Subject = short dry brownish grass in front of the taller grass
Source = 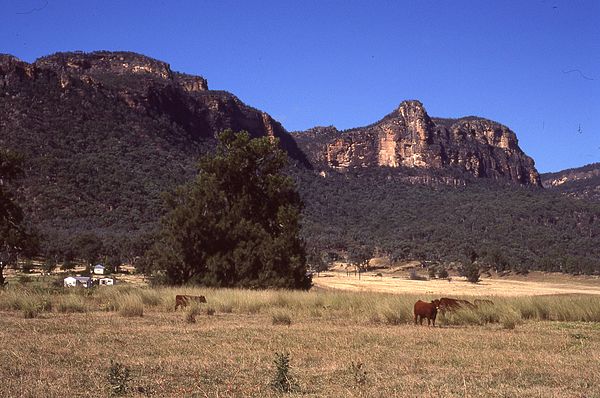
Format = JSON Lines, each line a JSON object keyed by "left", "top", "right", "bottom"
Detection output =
{"left": 0, "top": 302, "right": 600, "bottom": 398}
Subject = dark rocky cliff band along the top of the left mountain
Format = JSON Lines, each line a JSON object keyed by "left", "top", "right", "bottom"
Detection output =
{"left": 0, "top": 51, "right": 305, "bottom": 162}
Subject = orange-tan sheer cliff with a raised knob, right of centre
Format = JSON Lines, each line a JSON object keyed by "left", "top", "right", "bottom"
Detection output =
{"left": 294, "top": 101, "right": 540, "bottom": 186}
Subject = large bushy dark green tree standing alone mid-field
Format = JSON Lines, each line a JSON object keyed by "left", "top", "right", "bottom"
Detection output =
{"left": 145, "top": 130, "right": 311, "bottom": 289}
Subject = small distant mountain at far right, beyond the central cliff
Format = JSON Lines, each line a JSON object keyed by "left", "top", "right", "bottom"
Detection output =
{"left": 541, "top": 163, "right": 600, "bottom": 201}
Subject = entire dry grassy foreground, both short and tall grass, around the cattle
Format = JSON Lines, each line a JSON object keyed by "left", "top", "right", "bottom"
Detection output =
{"left": 0, "top": 288, "right": 600, "bottom": 397}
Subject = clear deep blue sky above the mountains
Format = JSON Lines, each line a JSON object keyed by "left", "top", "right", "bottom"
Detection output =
{"left": 0, "top": 0, "right": 600, "bottom": 172}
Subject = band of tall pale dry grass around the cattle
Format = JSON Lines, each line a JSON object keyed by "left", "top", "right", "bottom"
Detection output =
{"left": 0, "top": 285, "right": 600, "bottom": 329}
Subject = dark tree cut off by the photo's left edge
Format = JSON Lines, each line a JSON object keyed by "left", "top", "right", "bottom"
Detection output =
{"left": 0, "top": 149, "right": 39, "bottom": 287}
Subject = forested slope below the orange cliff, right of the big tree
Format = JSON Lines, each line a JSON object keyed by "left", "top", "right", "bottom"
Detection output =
{"left": 296, "top": 170, "right": 600, "bottom": 273}
